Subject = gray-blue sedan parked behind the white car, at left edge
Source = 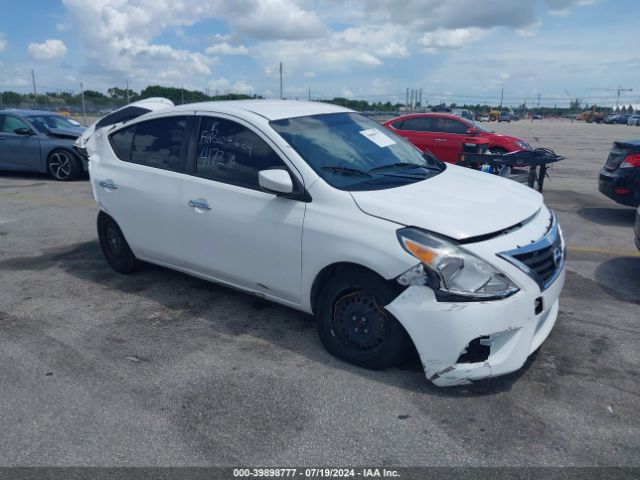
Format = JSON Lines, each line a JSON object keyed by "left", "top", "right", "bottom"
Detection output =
{"left": 0, "top": 110, "right": 87, "bottom": 180}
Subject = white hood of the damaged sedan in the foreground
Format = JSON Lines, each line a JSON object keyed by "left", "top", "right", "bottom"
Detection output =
{"left": 351, "top": 165, "right": 542, "bottom": 240}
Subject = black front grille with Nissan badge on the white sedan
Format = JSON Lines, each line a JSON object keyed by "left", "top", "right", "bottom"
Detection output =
{"left": 499, "top": 214, "right": 566, "bottom": 290}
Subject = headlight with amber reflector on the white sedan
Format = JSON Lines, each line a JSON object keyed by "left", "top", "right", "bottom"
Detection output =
{"left": 397, "top": 228, "right": 518, "bottom": 301}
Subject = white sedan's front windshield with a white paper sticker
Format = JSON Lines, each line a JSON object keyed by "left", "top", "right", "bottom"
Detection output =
{"left": 271, "top": 113, "right": 445, "bottom": 191}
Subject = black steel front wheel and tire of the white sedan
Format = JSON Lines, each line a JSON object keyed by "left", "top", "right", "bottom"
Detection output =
{"left": 316, "top": 270, "right": 411, "bottom": 370}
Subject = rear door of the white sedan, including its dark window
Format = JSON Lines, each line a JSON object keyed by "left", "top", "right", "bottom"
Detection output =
{"left": 91, "top": 115, "right": 195, "bottom": 266}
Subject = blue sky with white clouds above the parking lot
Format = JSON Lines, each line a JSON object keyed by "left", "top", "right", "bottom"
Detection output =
{"left": 0, "top": 0, "right": 640, "bottom": 106}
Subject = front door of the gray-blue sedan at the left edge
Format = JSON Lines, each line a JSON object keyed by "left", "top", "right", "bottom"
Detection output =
{"left": 0, "top": 114, "right": 43, "bottom": 171}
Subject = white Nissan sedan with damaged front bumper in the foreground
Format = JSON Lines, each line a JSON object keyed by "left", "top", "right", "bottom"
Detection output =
{"left": 89, "top": 100, "right": 565, "bottom": 386}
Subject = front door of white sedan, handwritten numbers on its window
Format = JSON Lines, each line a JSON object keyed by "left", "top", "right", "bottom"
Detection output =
{"left": 180, "top": 115, "right": 306, "bottom": 303}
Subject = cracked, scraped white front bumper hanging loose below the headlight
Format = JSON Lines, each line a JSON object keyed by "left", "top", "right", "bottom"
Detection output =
{"left": 386, "top": 269, "right": 565, "bottom": 386}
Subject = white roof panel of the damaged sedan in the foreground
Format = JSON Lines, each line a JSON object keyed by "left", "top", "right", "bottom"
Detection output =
{"left": 168, "top": 100, "right": 353, "bottom": 120}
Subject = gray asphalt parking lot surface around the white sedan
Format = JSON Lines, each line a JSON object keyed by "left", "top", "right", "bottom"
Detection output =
{"left": 0, "top": 120, "right": 640, "bottom": 466}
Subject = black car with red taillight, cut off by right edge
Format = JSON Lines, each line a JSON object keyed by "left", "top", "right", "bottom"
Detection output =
{"left": 598, "top": 139, "right": 640, "bottom": 207}
